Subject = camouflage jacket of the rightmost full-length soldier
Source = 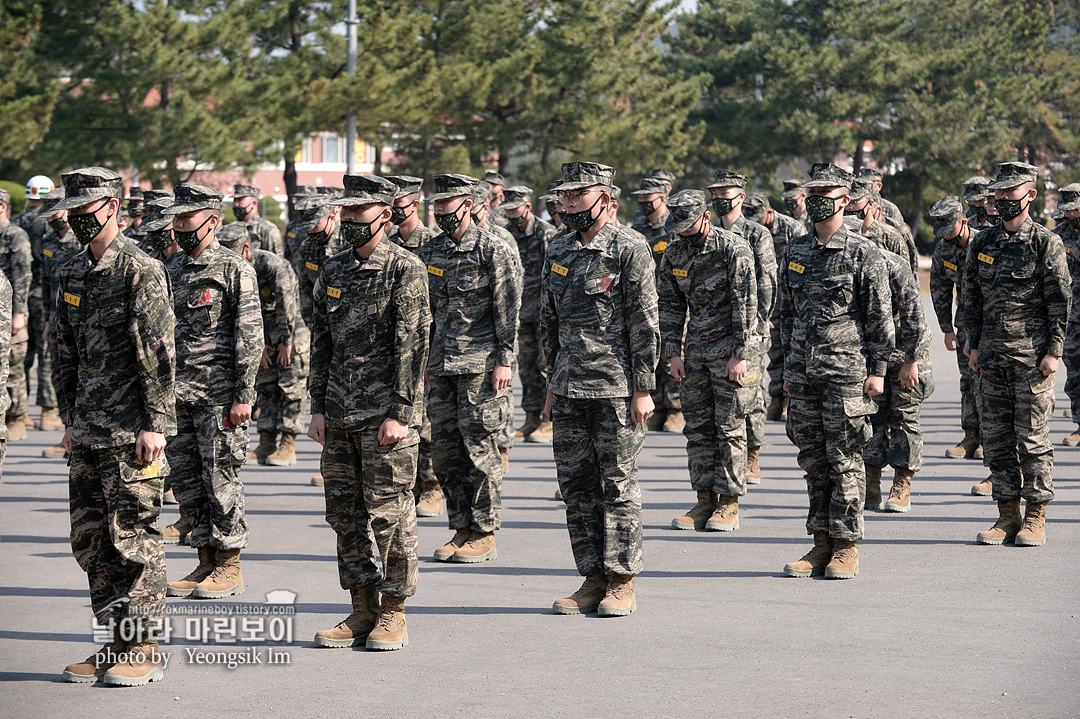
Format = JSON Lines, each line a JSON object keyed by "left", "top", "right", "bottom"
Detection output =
{"left": 963, "top": 218, "right": 1072, "bottom": 367}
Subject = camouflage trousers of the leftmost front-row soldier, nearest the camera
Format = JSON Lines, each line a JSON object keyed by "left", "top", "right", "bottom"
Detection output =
{"left": 68, "top": 444, "right": 170, "bottom": 625}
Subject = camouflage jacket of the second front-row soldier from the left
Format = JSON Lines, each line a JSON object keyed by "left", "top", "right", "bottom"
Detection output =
{"left": 309, "top": 238, "right": 429, "bottom": 430}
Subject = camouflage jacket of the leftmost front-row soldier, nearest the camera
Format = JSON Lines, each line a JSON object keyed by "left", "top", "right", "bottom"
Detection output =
{"left": 52, "top": 235, "right": 176, "bottom": 449}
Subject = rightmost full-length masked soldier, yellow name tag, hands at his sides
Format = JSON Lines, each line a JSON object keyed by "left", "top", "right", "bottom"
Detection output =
{"left": 963, "top": 162, "right": 1072, "bottom": 546}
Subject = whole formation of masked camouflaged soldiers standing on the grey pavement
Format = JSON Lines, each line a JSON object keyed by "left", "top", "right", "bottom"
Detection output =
{"left": 0, "top": 154, "right": 1080, "bottom": 686}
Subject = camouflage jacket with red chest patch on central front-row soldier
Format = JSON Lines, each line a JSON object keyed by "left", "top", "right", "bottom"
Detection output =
{"left": 540, "top": 221, "right": 660, "bottom": 398}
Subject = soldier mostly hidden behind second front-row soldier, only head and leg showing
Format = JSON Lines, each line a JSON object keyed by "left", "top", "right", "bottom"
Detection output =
{"left": 387, "top": 175, "right": 443, "bottom": 517}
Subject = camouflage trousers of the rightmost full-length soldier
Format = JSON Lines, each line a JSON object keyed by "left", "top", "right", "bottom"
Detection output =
{"left": 978, "top": 364, "right": 1055, "bottom": 502}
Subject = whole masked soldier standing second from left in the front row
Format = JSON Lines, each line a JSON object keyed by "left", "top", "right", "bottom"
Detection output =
{"left": 308, "top": 175, "right": 431, "bottom": 650}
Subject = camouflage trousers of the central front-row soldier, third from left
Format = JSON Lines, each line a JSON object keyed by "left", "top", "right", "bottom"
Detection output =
{"left": 551, "top": 394, "right": 645, "bottom": 576}
